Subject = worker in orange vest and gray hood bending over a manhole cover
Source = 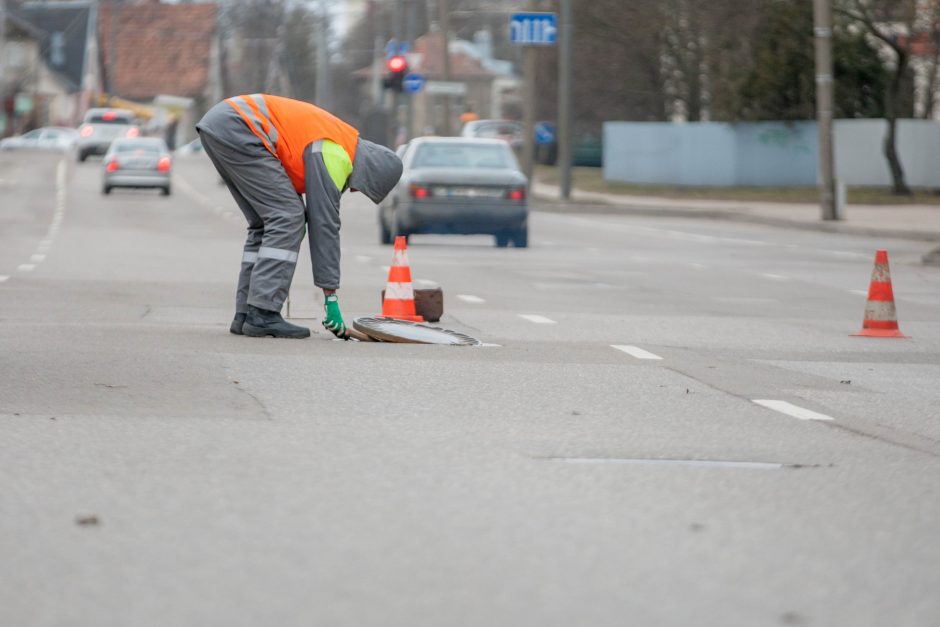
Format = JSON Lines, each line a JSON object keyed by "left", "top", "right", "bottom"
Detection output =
{"left": 196, "top": 94, "right": 402, "bottom": 339}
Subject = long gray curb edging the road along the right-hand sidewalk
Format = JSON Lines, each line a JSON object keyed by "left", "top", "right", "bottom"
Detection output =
{"left": 532, "top": 193, "right": 940, "bottom": 242}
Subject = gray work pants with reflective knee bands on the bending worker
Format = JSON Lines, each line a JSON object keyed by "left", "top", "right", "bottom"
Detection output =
{"left": 198, "top": 123, "right": 306, "bottom": 313}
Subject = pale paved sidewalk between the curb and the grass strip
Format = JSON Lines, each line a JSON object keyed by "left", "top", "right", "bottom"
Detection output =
{"left": 532, "top": 181, "right": 940, "bottom": 242}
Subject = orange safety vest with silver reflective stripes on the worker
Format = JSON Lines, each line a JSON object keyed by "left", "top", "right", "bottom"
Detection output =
{"left": 226, "top": 94, "right": 359, "bottom": 194}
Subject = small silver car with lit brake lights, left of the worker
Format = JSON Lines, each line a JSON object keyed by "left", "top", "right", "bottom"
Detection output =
{"left": 101, "top": 137, "right": 173, "bottom": 196}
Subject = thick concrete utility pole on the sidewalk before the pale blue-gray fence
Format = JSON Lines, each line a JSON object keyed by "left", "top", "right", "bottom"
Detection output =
{"left": 813, "top": 0, "right": 841, "bottom": 220}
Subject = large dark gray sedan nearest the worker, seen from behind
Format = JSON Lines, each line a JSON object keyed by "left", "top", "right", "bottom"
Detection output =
{"left": 379, "top": 137, "right": 529, "bottom": 248}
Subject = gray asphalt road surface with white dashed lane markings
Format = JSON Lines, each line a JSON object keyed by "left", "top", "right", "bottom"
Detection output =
{"left": 0, "top": 153, "right": 940, "bottom": 627}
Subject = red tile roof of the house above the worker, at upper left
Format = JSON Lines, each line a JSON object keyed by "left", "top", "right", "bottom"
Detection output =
{"left": 98, "top": 2, "right": 218, "bottom": 100}
